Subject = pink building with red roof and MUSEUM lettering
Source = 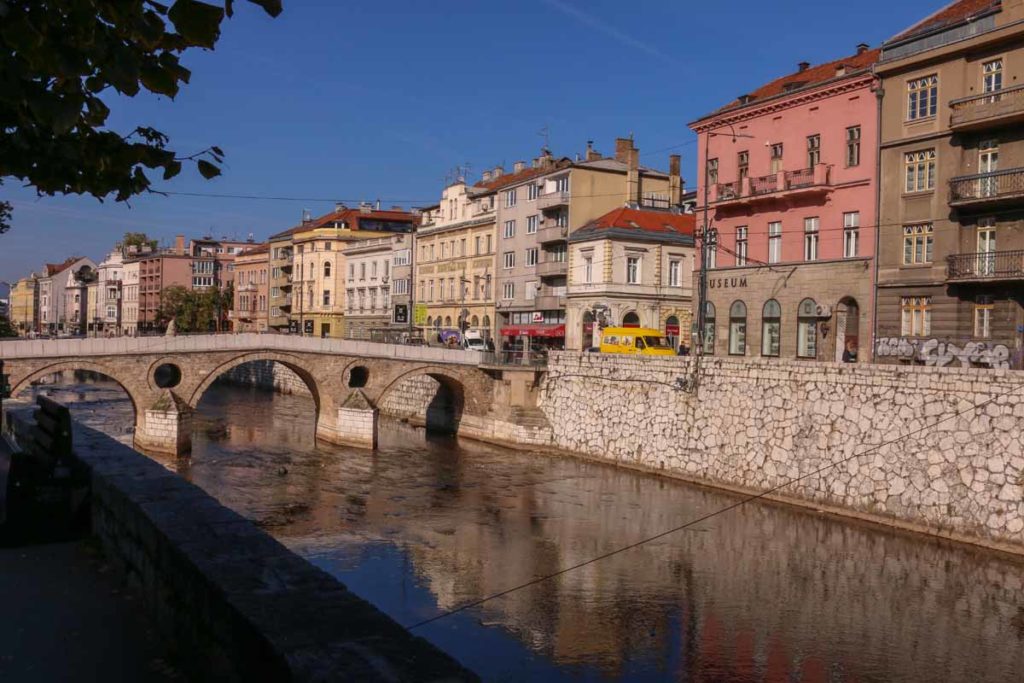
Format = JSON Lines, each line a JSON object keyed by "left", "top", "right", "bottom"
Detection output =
{"left": 690, "top": 45, "right": 879, "bottom": 361}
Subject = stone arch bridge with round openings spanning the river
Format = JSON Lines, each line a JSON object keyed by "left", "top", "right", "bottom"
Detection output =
{"left": 0, "top": 334, "right": 539, "bottom": 455}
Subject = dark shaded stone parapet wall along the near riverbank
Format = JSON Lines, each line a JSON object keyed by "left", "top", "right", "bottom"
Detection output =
{"left": 5, "top": 401, "right": 478, "bottom": 682}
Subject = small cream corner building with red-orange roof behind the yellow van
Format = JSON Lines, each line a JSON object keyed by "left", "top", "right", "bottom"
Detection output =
{"left": 565, "top": 204, "right": 695, "bottom": 350}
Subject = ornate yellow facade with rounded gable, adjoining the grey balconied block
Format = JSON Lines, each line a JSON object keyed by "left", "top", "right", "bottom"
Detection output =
{"left": 413, "top": 179, "right": 497, "bottom": 342}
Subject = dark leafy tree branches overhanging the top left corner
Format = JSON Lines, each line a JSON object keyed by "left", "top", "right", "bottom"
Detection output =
{"left": 0, "top": 0, "right": 282, "bottom": 232}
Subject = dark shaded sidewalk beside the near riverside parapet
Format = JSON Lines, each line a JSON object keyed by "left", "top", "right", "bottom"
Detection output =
{"left": 0, "top": 438, "right": 185, "bottom": 683}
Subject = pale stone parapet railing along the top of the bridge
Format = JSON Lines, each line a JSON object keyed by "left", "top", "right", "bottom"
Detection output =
{"left": 0, "top": 333, "right": 483, "bottom": 366}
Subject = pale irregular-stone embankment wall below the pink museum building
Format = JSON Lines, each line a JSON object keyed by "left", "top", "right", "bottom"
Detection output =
{"left": 541, "top": 352, "right": 1024, "bottom": 552}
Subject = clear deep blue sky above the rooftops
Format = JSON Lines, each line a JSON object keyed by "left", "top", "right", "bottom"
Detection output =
{"left": 0, "top": 0, "right": 941, "bottom": 281}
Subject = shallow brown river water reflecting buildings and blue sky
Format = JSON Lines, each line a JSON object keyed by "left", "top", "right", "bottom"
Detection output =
{"left": 19, "top": 382, "right": 1024, "bottom": 683}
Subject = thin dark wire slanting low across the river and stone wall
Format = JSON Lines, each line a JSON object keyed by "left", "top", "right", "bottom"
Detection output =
{"left": 406, "top": 374, "right": 1024, "bottom": 631}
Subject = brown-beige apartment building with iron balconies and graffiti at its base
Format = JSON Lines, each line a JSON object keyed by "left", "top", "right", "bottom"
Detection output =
{"left": 874, "top": 0, "right": 1024, "bottom": 368}
